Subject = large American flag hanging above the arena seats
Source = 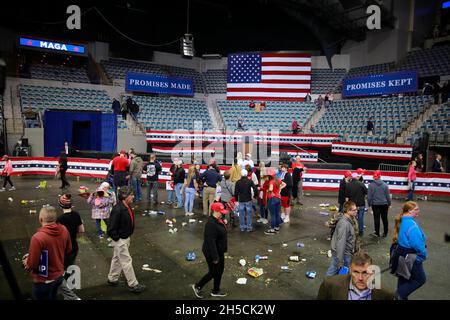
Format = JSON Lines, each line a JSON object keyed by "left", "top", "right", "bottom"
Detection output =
{"left": 227, "top": 52, "right": 311, "bottom": 100}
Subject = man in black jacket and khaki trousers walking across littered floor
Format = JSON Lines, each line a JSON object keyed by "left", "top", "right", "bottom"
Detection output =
{"left": 108, "top": 186, "right": 145, "bottom": 293}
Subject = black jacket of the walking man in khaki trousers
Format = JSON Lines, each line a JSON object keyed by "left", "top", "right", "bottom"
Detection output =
{"left": 107, "top": 201, "right": 134, "bottom": 241}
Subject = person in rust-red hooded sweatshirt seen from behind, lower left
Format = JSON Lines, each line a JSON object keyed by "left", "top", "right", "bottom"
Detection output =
{"left": 22, "top": 206, "right": 72, "bottom": 300}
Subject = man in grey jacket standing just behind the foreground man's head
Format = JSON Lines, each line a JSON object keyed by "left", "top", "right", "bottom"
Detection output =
{"left": 326, "top": 201, "right": 357, "bottom": 276}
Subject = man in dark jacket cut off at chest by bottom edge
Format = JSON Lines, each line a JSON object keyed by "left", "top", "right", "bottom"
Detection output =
{"left": 317, "top": 251, "right": 394, "bottom": 300}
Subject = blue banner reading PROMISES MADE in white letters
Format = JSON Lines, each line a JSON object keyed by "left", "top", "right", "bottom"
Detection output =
{"left": 125, "top": 72, "right": 194, "bottom": 96}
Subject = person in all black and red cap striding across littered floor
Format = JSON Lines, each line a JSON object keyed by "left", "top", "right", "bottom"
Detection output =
{"left": 191, "top": 202, "right": 228, "bottom": 299}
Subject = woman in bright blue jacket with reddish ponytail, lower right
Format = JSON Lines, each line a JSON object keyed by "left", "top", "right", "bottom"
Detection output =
{"left": 393, "top": 201, "right": 427, "bottom": 300}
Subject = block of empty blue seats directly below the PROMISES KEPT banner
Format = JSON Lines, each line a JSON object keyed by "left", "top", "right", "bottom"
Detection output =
{"left": 315, "top": 96, "right": 432, "bottom": 143}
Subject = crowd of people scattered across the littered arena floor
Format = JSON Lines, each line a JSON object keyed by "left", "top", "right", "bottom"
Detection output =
{"left": 5, "top": 149, "right": 442, "bottom": 300}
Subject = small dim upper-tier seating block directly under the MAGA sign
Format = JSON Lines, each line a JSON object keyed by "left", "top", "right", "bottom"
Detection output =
{"left": 30, "top": 65, "right": 89, "bottom": 83}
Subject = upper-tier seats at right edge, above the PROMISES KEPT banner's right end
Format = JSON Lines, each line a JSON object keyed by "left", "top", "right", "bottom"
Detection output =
{"left": 398, "top": 46, "right": 450, "bottom": 77}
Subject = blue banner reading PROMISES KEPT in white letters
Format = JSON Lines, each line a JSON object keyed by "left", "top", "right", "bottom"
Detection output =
{"left": 342, "top": 71, "right": 418, "bottom": 98}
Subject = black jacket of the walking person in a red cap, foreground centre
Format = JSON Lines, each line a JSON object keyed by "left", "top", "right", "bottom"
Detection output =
{"left": 202, "top": 215, "right": 228, "bottom": 261}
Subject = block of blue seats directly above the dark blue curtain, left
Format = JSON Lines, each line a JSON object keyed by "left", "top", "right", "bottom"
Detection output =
{"left": 19, "top": 84, "right": 112, "bottom": 112}
